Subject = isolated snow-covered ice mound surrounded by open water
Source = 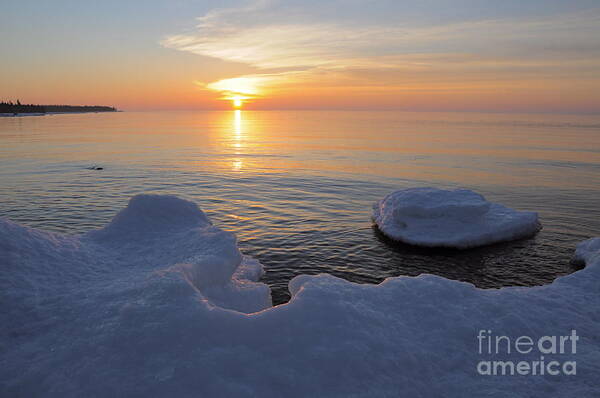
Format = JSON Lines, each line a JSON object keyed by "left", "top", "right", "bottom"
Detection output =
{"left": 373, "top": 188, "right": 540, "bottom": 249}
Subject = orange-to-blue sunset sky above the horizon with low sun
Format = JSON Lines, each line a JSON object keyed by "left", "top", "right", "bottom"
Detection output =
{"left": 0, "top": 0, "right": 600, "bottom": 113}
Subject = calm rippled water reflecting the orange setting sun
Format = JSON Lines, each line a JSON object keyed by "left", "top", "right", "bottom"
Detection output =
{"left": 0, "top": 111, "right": 600, "bottom": 303}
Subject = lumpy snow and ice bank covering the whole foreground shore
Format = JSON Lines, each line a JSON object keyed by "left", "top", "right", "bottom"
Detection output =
{"left": 0, "top": 195, "right": 600, "bottom": 397}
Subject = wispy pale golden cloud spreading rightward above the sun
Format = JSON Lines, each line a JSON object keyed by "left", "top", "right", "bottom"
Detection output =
{"left": 161, "top": 0, "right": 600, "bottom": 105}
